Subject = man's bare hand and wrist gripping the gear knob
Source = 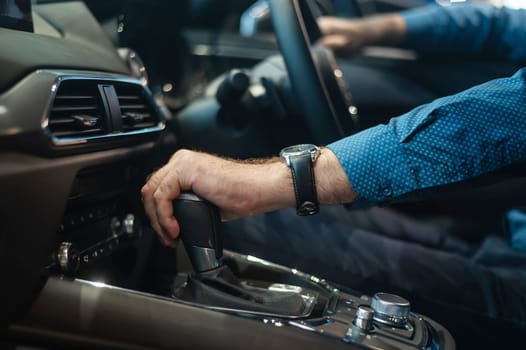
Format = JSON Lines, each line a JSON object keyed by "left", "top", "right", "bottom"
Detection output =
{"left": 141, "top": 148, "right": 356, "bottom": 246}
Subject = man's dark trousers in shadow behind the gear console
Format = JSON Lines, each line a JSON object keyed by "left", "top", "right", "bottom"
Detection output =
{"left": 224, "top": 206, "right": 526, "bottom": 349}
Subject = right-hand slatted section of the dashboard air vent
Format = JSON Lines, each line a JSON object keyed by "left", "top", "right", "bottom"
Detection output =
{"left": 115, "top": 84, "right": 159, "bottom": 132}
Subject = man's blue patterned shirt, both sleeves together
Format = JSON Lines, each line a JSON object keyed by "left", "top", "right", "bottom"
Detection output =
{"left": 328, "top": 5, "right": 526, "bottom": 248}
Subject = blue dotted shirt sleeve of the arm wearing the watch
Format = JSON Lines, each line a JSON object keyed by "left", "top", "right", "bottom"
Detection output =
{"left": 328, "top": 68, "right": 526, "bottom": 205}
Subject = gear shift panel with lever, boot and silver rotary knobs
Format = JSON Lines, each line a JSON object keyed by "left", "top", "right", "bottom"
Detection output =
{"left": 168, "top": 193, "right": 455, "bottom": 349}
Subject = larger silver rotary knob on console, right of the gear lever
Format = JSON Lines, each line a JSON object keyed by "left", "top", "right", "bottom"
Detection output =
{"left": 371, "top": 293, "right": 411, "bottom": 327}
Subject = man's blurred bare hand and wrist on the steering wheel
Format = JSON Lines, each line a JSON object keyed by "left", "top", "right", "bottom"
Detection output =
{"left": 317, "top": 14, "right": 406, "bottom": 56}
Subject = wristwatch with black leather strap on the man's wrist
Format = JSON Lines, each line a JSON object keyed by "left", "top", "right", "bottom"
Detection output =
{"left": 279, "top": 144, "right": 320, "bottom": 215}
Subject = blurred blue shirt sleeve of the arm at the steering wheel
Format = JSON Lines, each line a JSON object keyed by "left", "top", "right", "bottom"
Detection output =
{"left": 401, "top": 4, "right": 526, "bottom": 62}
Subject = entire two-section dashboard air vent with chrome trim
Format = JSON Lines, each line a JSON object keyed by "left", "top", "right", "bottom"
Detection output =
{"left": 45, "top": 74, "right": 164, "bottom": 149}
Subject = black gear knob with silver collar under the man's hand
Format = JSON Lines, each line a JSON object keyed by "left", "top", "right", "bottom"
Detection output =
{"left": 173, "top": 192, "right": 223, "bottom": 273}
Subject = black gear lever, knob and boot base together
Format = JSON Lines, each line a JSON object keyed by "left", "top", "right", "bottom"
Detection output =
{"left": 173, "top": 192, "right": 312, "bottom": 316}
